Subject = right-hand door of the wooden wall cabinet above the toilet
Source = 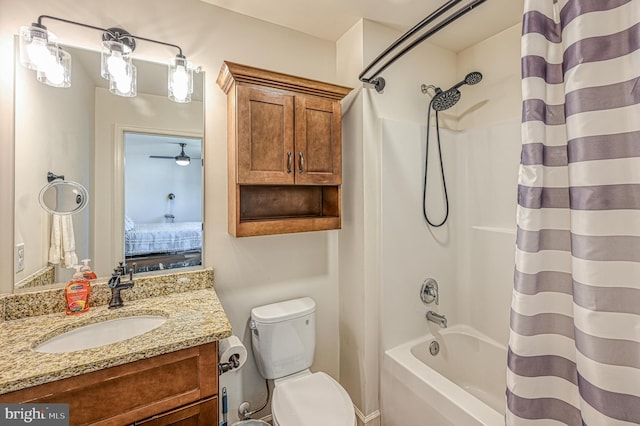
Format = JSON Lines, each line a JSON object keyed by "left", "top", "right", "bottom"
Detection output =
{"left": 295, "top": 96, "right": 342, "bottom": 185}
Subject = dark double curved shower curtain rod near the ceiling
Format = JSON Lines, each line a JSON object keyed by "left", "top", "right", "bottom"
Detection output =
{"left": 358, "top": 0, "right": 486, "bottom": 93}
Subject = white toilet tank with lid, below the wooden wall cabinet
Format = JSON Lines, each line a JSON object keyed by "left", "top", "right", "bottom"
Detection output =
{"left": 250, "top": 297, "right": 316, "bottom": 379}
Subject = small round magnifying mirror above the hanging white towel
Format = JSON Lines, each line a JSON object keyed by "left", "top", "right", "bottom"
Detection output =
{"left": 40, "top": 180, "right": 89, "bottom": 214}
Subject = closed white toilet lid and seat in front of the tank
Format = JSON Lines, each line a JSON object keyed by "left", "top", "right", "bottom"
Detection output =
{"left": 271, "top": 372, "right": 356, "bottom": 426}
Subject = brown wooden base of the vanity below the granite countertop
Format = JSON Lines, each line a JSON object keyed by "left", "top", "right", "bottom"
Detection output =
{"left": 0, "top": 342, "right": 218, "bottom": 426}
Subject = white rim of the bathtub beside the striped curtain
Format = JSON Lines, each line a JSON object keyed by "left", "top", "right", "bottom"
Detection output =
{"left": 385, "top": 324, "right": 506, "bottom": 426}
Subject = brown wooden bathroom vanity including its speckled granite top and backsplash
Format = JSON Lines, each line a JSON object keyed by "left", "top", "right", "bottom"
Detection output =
{"left": 0, "top": 270, "right": 231, "bottom": 426}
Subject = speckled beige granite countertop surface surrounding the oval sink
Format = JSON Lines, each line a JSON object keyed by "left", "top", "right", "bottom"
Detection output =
{"left": 0, "top": 270, "right": 231, "bottom": 394}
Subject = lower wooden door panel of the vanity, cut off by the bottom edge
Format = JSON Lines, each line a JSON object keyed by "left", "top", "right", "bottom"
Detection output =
{"left": 134, "top": 397, "right": 218, "bottom": 426}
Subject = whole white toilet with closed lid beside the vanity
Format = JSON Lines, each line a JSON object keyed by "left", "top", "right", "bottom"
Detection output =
{"left": 251, "top": 297, "right": 356, "bottom": 426}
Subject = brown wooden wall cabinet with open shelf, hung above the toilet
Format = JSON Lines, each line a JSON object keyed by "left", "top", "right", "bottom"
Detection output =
{"left": 218, "top": 62, "right": 351, "bottom": 237}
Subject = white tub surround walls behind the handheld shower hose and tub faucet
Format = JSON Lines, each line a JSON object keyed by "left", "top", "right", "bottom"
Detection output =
{"left": 380, "top": 25, "right": 521, "bottom": 360}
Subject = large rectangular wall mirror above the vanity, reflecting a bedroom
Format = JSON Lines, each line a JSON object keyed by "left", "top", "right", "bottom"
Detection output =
{"left": 14, "top": 39, "right": 204, "bottom": 289}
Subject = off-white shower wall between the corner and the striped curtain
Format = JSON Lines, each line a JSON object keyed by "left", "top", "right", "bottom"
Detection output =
{"left": 456, "top": 24, "right": 522, "bottom": 345}
